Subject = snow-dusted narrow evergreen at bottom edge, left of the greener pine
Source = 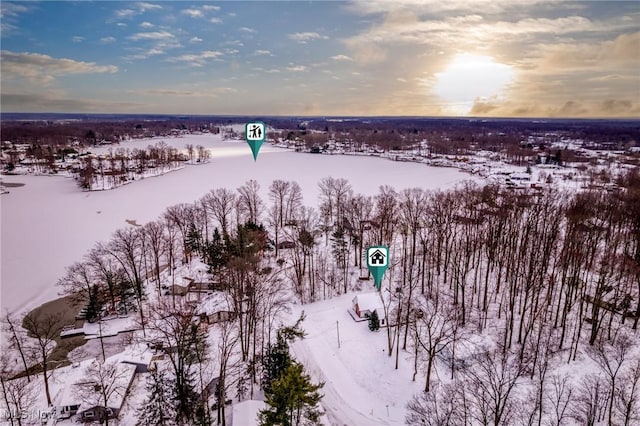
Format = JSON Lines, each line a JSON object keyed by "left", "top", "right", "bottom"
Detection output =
{"left": 136, "top": 368, "right": 176, "bottom": 426}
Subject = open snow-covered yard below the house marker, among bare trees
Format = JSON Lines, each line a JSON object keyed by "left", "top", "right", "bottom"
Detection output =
{"left": 292, "top": 293, "right": 422, "bottom": 425}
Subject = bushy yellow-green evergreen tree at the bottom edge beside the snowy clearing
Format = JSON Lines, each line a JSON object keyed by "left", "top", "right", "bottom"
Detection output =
{"left": 260, "top": 362, "right": 324, "bottom": 426}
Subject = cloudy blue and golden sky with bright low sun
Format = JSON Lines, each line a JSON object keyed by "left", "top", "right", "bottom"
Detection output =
{"left": 0, "top": 0, "right": 640, "bottom": 117}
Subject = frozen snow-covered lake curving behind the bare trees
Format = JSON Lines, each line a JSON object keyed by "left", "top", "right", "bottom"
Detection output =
{"left": 0, "top": 135, "right": 476, "bottom": 312}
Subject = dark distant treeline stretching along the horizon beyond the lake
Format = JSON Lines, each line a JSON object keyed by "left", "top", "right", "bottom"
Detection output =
{"left": 1, "top": 114, "right": 640, "bottom": 149}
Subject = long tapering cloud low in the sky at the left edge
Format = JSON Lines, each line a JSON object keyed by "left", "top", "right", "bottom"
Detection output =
{"left": 1, "top": 50, "right": 118, "bottom": 84}
